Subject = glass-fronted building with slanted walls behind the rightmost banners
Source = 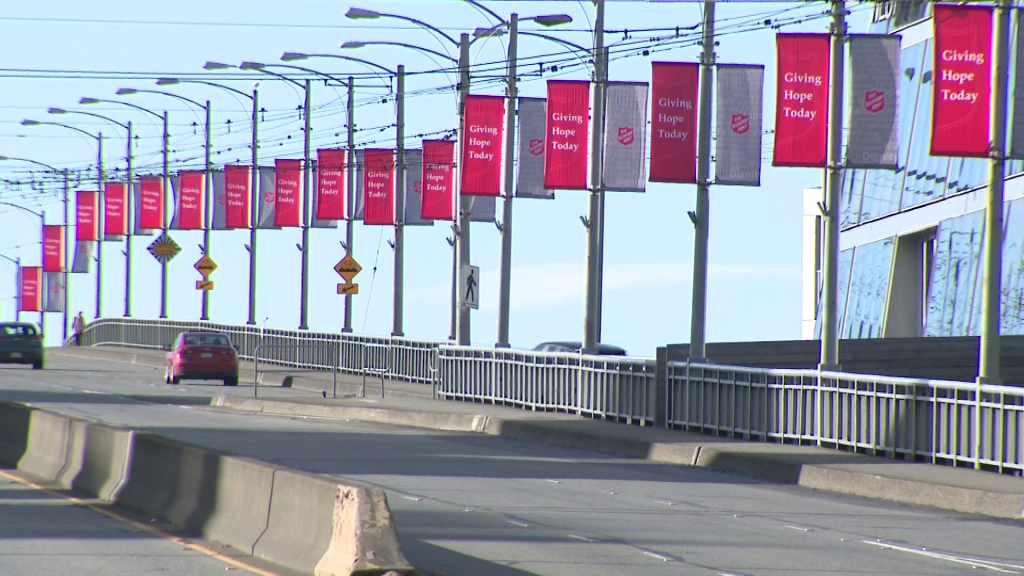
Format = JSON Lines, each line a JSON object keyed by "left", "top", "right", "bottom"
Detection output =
{"left": 804, "top": 0, "right": 1024, "bottom": 338}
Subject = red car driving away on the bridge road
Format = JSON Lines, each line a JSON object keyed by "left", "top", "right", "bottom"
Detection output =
{"left": 164, "top": 332, "right": 239, "bottom": 386}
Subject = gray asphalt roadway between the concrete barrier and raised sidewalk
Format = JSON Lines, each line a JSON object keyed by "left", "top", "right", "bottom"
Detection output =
{"left": 0, "top": 356, "right": 1024, "bottom": 576}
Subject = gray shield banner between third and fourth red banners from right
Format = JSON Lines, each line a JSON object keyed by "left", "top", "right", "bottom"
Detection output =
{"left": 601, "top": 82, "right": 649, "bottom": 192}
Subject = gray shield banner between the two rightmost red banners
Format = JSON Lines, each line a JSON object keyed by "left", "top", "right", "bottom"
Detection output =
{"left": 846, "top": 34, "right": 900, "bottom": 170}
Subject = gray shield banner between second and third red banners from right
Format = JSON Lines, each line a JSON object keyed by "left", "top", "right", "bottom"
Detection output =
{"left": 715, "top": 65, "right": 765, "bottom": 187}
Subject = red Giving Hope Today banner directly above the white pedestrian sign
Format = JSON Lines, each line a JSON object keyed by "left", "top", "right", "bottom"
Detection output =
{"left": 459, "top": 96, "right": 505, "bottom": 196}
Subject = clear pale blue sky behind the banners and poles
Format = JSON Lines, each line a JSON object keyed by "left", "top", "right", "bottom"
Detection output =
{"left": 0, "top": 0, "right": 870, "bottom": 356}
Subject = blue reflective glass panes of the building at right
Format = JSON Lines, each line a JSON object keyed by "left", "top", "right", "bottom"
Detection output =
{"left": 827, "top": 2, "right": 1024, "bottom": 338}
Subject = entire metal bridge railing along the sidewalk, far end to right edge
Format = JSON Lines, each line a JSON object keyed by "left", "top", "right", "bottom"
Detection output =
{"left": 74, "top": 318, "right": 1024, "bottom": 475}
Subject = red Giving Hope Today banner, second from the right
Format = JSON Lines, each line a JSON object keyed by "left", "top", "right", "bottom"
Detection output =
{"left": 772, "top": 34, "right": 831, "bottom": 168}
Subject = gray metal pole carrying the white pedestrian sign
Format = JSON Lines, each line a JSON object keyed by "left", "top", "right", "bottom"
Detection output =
{"left": 452, "top": 34, "right": 472, "bottom": 346}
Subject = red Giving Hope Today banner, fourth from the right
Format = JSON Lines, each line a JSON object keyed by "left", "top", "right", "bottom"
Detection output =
{"left": 544, "top": 80, "right": 590, "bottom": 190}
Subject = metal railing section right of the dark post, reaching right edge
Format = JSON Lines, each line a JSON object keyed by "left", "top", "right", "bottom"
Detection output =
{"left": 667, "top": 362, "right": 1024, "bottom": 475}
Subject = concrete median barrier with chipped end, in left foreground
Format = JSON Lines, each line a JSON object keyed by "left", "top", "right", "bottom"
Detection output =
{"left": 0, "top": 402, "right": 416, "bottom": 576}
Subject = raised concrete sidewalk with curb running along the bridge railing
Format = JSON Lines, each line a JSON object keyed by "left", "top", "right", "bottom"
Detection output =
{"left": 51, "top": 348, "right": 1024, "bottom": 521}
